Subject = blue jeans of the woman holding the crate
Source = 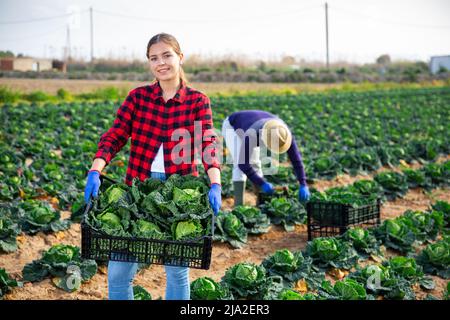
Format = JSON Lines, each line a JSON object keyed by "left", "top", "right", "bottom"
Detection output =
{"left": 108, "top": 172, "right": 191, "bottom": 300}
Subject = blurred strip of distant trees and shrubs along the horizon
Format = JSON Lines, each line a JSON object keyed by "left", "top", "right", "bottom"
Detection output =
{"left": 0, "top": 51, "right": 450, "bottom": 83}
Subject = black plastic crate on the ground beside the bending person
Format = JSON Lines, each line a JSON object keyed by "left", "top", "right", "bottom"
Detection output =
{"left": 306, "top": 199, "right": 381, "bottom": 240}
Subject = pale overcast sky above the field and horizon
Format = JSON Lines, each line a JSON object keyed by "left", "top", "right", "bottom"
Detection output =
{"left": 0, "top": 0, "right": 450, "bottom": 63}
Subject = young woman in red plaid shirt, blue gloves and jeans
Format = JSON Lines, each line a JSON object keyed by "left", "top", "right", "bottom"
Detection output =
{"left": 85, "top": 33, "right": 222, "bottom": 300}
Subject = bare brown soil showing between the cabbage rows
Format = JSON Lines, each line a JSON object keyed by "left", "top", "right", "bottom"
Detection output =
{"left": 0, "top": 188, "right": 450, "bottom": 300}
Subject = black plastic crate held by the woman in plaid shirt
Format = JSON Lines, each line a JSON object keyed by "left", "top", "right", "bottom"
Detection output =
{"left": 81, "top": 188, "right": 214, "bottom": 269}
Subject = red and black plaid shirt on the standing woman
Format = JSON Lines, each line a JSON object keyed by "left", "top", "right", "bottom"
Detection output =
{"left": 95, "top": 82, "right": 220, "bottom": 185}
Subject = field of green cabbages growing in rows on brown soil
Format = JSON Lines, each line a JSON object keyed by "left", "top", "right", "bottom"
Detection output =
{"left": 0, "top": 87, "right": 450, "bottom": 300}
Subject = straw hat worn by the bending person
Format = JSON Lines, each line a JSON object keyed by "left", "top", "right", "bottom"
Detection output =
{"left": 261, "top": 119, "right": 292, "bottom": 154}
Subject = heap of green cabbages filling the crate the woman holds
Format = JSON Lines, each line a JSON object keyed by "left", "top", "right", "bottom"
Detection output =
{"left": 87, "top": 175, "right": 212, "bottom": 241}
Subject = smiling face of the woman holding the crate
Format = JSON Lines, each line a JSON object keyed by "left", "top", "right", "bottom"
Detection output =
{"left": 149, "top": 41, "right": 183, "bottom": 81}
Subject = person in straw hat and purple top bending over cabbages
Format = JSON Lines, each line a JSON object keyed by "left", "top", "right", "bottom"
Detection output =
{"left": 222, "top": 110, "right": 310, "bottom": 206}
